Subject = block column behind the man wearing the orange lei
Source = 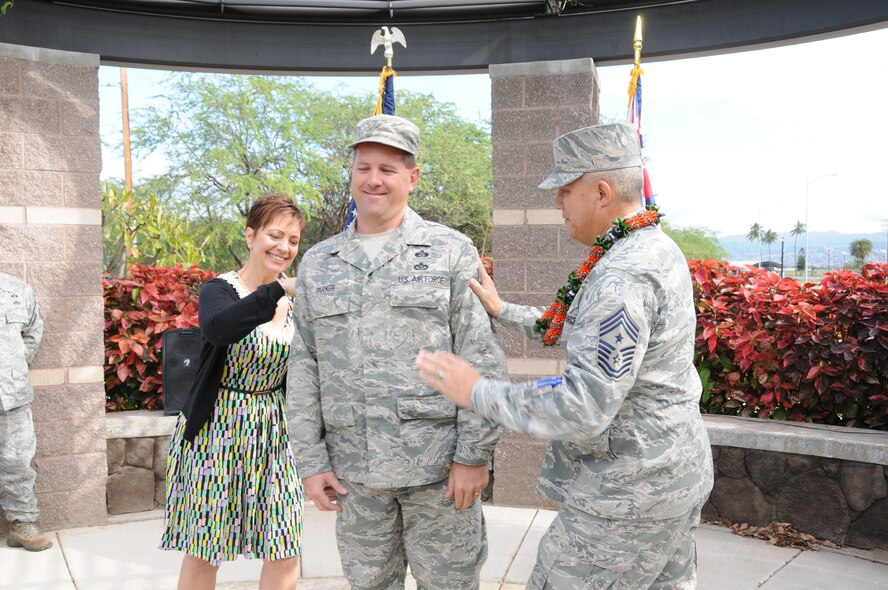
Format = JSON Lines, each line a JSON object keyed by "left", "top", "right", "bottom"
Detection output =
{"left": 490, "top": 59, "right": 598, "bottom": 506}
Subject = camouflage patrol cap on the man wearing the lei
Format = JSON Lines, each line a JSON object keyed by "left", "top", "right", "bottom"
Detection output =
{"left": 539, "top": 123, "right": 641, "bottom": 188}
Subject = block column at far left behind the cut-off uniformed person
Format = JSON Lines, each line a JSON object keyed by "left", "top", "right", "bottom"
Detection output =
{"left": 0, "top": 43, "right": 107, "bottom": 535}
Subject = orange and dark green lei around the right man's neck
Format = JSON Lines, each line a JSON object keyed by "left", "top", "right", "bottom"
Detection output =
{"left": 534, "top": 205, "right": 663, "bottom": 346}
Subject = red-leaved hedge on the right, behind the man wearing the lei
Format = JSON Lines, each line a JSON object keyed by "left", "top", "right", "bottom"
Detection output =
{"left": 690, "top": 260, "right": 888, "bottom": 430}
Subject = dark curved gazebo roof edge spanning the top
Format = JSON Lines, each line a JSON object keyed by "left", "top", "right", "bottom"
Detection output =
{"left": 0, "top": 0, "right": 888, "bottom": 74}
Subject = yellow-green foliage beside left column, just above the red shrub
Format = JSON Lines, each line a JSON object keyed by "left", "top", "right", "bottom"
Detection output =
{"left": 102, "top": 182, "right": 201, "bottom": 277}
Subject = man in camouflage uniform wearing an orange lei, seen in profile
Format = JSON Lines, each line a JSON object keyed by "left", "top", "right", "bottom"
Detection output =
{"left": 417, "top": 124, "right": 713, "bottom": 590}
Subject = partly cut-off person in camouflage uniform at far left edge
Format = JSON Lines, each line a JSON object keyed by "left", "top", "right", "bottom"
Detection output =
{"left": 0, "top": 273, "right": 52, "bottom": 551}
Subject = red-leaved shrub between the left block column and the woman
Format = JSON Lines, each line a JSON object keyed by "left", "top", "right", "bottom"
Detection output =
{"left": 102, "top": 264, "right": 216, "bottom": 411}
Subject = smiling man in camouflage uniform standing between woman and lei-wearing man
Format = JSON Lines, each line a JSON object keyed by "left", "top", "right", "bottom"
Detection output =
{"left": 287, "top": 115, "right": 505, "bottom": 590}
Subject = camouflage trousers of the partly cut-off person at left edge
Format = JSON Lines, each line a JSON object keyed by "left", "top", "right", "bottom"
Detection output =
{"left": 0, "top": 404, "right": 38, "bottom": 522}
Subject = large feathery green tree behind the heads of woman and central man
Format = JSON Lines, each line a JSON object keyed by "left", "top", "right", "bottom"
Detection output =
{"left": 133, "top": 74, "right": 493, "bottom": 269}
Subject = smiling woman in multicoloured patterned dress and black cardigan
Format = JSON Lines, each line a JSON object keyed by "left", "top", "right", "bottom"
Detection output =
{"left": 160, "top": 194, "right": 305, "bottom": 590}
